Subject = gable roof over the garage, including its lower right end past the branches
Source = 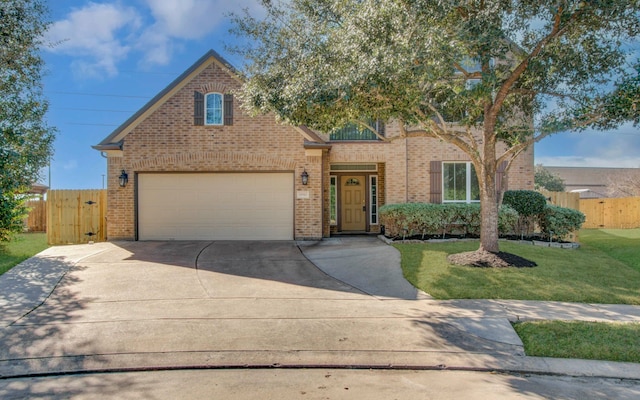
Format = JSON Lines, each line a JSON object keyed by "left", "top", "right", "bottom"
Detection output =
{"left": 91, "top": 50, "right": 324, "bottom": 153}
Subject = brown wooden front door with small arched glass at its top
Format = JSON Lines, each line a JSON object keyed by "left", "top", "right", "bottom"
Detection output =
{"left": 340, "top": 175, "right": 367, "bottom": 231}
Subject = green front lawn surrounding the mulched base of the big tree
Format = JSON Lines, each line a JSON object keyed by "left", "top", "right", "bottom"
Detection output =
{"left": 395, "top": 229, "right": 640, "bottom": 305}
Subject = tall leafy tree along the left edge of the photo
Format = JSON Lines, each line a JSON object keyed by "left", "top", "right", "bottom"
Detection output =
{"left": 0, "top": 0, "right": 54, "bottom": 241}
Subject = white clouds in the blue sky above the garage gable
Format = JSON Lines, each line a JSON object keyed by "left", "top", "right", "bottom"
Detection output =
{"left": 47, "top": 0, "right": 263, "bottom": 78}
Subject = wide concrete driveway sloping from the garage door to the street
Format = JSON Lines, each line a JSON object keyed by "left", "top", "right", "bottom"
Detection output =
{"left": 0, "top": 241, "right": 521, "bottom": 377}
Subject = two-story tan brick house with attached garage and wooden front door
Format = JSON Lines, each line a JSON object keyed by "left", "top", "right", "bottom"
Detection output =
{"left": 94, "top": 51, "right": 534, "bottom": 240}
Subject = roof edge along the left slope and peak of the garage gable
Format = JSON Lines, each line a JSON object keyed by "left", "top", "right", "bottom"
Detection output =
{"left": 92, "top": 49, "right": 242, "bottom": 150}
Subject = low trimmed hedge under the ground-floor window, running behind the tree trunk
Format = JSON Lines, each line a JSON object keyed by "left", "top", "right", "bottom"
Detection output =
{"left": 380, "top": 203, "right": 518, "bottom": 238}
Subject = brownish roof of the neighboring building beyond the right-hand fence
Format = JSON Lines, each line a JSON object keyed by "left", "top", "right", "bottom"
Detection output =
{"left": 544, "top": 166, "right": 640, "bottom": 199}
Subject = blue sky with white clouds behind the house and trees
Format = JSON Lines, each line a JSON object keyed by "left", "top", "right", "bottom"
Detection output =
{"left": 41, "top": 0, "right": 640, "bottom": 189}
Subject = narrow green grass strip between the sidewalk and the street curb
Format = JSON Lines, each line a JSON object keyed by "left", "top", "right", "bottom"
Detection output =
{"left": 513, "top": 321, "right": 640, "bottom": 363}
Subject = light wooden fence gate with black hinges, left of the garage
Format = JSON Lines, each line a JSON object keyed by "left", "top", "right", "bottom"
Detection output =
{"left": 47, "top": 190, "right": 107, "bottom": 245}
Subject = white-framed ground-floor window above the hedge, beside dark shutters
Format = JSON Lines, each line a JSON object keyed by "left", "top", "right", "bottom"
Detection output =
{"left": 442, "top": 162, "right": 480, "bottom": 203}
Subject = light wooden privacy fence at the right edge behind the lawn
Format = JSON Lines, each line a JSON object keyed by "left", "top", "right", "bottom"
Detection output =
{"left": 580, "top": 197, "right": 640, "bottom": 229}
